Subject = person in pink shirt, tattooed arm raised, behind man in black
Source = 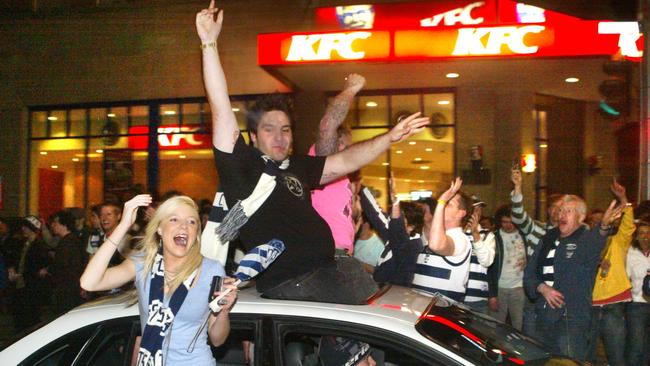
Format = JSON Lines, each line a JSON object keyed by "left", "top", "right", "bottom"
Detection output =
{"left": 309, "top": 74, "right": 366, "bottom": 255}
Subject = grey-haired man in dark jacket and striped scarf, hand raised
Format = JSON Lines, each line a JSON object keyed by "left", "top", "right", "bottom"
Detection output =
{"left": 524, "top": 195, "right": 623, "bottom": 360}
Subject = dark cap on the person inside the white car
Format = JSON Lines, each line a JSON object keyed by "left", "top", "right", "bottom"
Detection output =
{"left": 318, "top": 336, "right": 370, "bottom": 366}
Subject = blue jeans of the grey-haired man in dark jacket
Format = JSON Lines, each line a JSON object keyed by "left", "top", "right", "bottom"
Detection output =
{"left": 537, "top": 315, "right": 590, "bottom": 361}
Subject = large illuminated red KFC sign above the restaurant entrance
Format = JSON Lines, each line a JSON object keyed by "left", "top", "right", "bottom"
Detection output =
{"left": 257, "top": 0, "right": 643, "bottom": 66}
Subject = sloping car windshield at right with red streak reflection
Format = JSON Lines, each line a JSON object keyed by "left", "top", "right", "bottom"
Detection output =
{"left": 416, "top": 294, "right": 551, "bottom": 365}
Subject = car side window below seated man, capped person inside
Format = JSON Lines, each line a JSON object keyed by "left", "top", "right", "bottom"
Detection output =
{"left": 276, "top": 320, "right": 451, "bottom": 366}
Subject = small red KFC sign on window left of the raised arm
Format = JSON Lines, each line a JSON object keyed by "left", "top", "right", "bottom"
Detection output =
{"left": 129, "top": 125, "right": 212, "bottom": 150}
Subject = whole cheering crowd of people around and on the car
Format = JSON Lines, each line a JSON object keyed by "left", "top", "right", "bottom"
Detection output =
{"left": 0, "top": 1, "right": 650, "bottom": 365}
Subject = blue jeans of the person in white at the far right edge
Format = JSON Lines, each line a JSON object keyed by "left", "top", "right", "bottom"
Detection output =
{"left": 627, "top": 302, "right": 650, "bottom": 366}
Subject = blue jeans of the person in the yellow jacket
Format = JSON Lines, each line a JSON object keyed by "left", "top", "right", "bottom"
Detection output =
{"left": 587, "top": 302, "right": 626, "bottom": 366}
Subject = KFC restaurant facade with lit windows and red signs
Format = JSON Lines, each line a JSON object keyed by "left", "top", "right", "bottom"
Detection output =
{"left": 0, "top": 0, "right": 642, "bottom": 219}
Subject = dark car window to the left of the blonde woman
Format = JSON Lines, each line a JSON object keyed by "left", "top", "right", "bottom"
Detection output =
{"left": 19, "top": 325, "right": 97, "bottom": 366}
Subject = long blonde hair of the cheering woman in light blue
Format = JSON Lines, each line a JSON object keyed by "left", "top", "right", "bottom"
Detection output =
{"left": 137, "top": 196, "right": 203, "bottom": 294}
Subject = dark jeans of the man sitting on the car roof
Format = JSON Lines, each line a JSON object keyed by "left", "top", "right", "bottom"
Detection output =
{"left": 262, "top": 256, "right": 379, "bottom": 305}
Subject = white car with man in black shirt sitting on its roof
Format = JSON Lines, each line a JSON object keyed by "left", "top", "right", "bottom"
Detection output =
{"left": 0, "top": 286, "right": 578, "bottom": 366}
